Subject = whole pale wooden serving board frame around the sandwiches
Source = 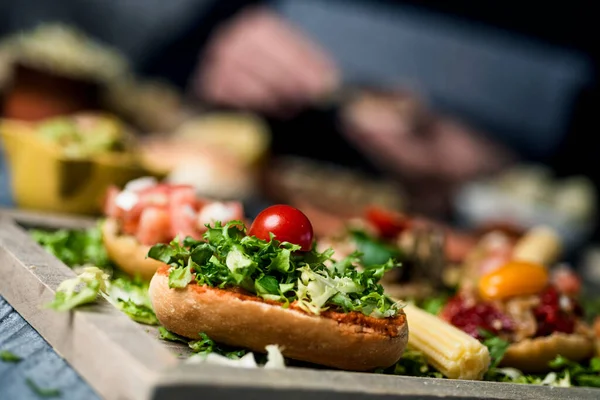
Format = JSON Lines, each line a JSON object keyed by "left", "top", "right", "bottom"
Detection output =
{"left": 0, "top": 210, "right": 600, "bottom": 400}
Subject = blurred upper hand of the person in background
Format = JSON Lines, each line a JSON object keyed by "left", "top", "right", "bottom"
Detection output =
{"left": 194, "top": 8, "right": 337, "bottom": 114}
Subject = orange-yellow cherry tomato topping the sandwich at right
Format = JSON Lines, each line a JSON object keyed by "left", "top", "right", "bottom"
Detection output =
{"left": 479, "top": 261, "right": 549, "bottom": 300}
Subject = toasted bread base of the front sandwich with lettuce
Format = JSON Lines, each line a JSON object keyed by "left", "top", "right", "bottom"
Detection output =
{"left": 150, "top": 267, "right": 408, "bottom": 371}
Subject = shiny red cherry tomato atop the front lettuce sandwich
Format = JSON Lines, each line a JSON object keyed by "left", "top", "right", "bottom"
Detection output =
{"left": 248, "top": 204, "right": 313, "bottom": 251}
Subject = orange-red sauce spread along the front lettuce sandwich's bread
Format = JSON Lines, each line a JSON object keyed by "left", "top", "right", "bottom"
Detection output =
{"left": 156, "top": 265, "right": 406, "bottom": 337}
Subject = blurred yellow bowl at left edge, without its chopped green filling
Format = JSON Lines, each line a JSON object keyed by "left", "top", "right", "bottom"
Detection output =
{"left": 0, "top": 120, "right": 156, "bottom": 214}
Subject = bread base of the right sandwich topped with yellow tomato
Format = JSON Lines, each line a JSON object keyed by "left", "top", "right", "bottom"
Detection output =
{"left": 501, "top": 332, "right": 594, "bottom": 373}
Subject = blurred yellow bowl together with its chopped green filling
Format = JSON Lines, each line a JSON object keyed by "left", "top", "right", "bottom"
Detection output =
{"left": 0, "top": 114, "right": 148, "bottom": 214}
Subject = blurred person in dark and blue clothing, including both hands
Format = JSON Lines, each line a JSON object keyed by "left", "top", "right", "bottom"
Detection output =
{"left": 0, "top": 0, "right": 598, "bottom": 216}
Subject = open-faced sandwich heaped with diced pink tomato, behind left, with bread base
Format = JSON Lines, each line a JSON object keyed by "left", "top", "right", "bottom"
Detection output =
{"left": 102, "top": 178, "right": 244, "bottom": 280}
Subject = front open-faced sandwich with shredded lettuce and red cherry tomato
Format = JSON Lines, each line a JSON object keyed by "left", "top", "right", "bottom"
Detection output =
{"left": 149, "top": 205, "right": 408, "bottom": 371}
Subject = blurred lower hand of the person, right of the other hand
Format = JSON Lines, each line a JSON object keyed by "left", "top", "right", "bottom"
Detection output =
{"left": 343, "top": 93, "right": 513, "bottom": 213}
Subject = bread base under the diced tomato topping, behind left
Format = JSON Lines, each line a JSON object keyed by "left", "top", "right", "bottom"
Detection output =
{"left": 102, "top": 218, "right": 165, "bottom": 281}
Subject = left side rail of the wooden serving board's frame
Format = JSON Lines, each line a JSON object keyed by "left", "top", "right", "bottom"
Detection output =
{"left": 0, "top": 218, "right": 178, "bottom": 399}
